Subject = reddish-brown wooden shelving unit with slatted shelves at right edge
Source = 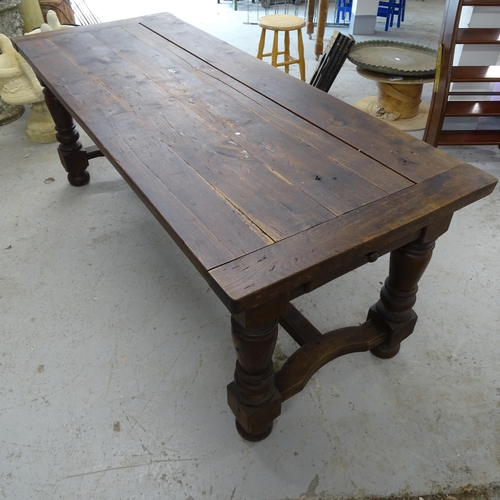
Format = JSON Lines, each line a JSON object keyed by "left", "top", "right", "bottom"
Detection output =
{"left": 423, "top": 0, "right": 500, "bottom": 146}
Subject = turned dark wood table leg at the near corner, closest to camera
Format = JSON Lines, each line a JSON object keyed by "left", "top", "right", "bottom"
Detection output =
{"left": 228, "top": 316, "right": 281, "bottom": 441}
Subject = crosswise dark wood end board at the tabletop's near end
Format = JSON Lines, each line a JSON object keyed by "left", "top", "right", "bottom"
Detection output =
{"left": 210, "top": 164, "right": 494, "bottom": 313}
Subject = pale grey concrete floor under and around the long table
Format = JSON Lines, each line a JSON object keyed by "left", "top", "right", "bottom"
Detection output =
{"left": 0, "top": 0, "right": 500, "bottom": 500}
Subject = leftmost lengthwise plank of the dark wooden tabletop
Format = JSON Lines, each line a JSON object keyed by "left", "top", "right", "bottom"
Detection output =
{"left": 22, "top": 39, "right": 278, "bottom": 268}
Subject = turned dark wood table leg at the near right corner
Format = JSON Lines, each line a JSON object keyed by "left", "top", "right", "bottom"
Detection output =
{"left": 368, "top": 241, "right": 434, "bottom": 359}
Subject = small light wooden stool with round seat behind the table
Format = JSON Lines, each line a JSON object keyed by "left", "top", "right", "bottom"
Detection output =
{"left": 257, "top": 14, "right": 306, "bottom": 82}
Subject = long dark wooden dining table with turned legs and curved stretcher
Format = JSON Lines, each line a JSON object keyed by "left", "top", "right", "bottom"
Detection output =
{"left": 14, "top": 13, "right": 497, "bottom": 441}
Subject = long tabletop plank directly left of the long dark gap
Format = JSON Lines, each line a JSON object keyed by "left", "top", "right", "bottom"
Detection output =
{"left": 90, "top": 22, "right": 411, "bottom": 204}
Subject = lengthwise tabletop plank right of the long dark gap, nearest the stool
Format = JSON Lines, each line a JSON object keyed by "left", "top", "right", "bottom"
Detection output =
{"left": 141, "top": 16, "right": 459, "bottom": 182}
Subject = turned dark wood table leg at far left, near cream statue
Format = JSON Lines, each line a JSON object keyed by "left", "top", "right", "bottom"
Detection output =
{"left": 42, "top": 83, "right": 90, "bottom": 186}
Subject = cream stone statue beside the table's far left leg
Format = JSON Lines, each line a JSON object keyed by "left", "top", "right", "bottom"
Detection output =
{"left": 0, "top": 34, "right": 56, "bottom": 143}
